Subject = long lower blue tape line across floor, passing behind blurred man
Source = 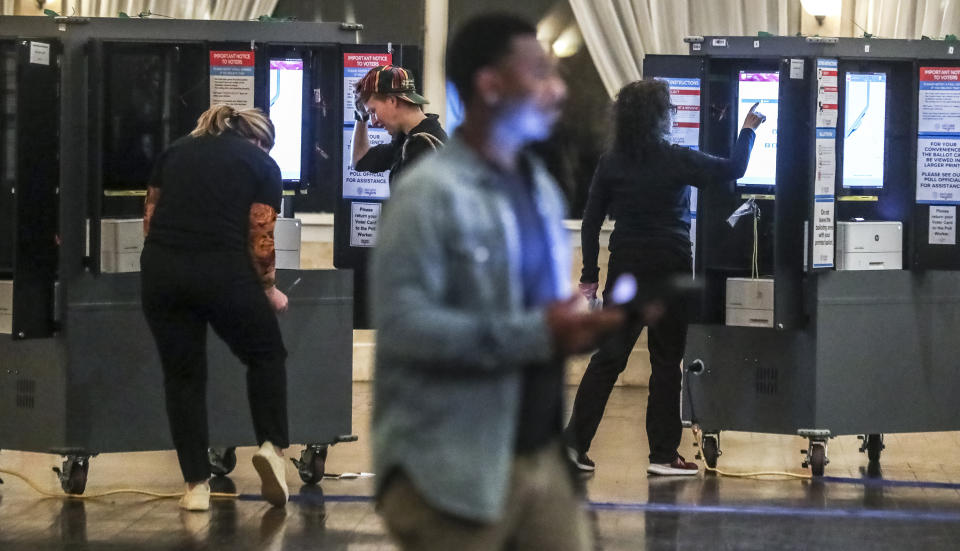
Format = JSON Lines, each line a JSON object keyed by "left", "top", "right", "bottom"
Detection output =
{"left": 238, "top": 493, "right": 960, "bottom": 522}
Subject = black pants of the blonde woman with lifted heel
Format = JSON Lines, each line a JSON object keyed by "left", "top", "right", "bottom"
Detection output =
{"left": 140, "top": 244, "right": 290, "bottom": 482}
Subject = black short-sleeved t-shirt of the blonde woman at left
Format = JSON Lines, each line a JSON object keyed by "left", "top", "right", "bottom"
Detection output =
{"left": 147, "top": 133, "right": 283, "bottom": 252}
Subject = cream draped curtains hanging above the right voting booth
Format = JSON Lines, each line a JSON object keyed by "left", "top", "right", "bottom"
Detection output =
{"left": 569, "top": 0, "right": 960, "bottom": 97}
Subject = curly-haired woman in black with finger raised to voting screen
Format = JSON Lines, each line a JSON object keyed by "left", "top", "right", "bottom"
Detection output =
{"left": 566, "top": 80, "right": 764, "bottom": 475}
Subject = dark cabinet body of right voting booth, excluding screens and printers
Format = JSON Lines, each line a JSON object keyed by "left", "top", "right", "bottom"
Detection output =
{"left": 644, "top": 37, "right": 960, "bottom": 475}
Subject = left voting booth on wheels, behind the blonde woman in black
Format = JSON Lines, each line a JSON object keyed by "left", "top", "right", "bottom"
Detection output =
{"left": 0, "top": 17, "right": 394, "bottom": 491}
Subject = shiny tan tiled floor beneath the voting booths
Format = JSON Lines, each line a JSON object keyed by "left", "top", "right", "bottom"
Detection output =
{"left": 0, "top": 384, "right": 960, "bottom": 551}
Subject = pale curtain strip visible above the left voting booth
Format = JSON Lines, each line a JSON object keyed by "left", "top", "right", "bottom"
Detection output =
{"left": 66, "top": 0, "right": 277, "bottom": 20}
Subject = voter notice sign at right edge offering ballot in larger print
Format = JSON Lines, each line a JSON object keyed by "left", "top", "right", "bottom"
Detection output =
{"left": 917, "top": 67, "right": 960, "bottom": 205}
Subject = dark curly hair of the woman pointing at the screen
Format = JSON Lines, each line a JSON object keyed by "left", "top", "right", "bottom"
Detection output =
{"left": 613, "top": 80, "right": 671, "bottom": 157}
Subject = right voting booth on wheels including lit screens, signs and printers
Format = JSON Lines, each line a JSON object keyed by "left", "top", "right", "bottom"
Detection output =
{"left": 644, "top": 37, "right": 960, "bottom": 474}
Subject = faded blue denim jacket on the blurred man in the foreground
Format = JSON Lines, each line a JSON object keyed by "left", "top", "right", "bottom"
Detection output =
{"left": 371, "top": 138, "right": 570, "bottom": 522}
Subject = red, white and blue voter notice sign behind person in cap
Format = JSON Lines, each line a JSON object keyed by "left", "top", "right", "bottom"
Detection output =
{"left": 343, "top": 53, "right": 393, "bottom": 201}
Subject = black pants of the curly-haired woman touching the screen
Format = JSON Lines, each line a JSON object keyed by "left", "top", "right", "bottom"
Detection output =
{"left": 566, "top": 249, "right": 691, "bottom": 463}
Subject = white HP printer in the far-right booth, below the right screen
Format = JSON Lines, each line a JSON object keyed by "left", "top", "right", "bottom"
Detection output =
{"left": 836, "top": 221, "right": 903, "bottom": 270}
